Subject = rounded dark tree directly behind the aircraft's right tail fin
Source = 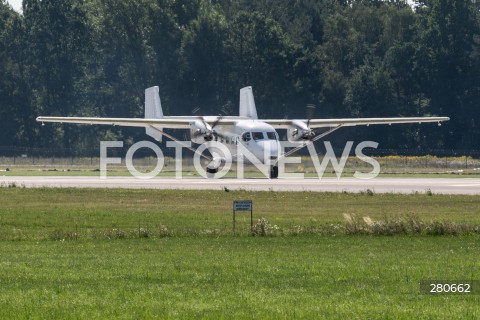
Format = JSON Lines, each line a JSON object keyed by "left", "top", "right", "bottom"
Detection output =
{"left": 227, "top": 11, "right": 295, "bottom": 116}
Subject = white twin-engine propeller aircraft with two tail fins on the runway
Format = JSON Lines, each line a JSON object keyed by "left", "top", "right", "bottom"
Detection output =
{"left": 37, "top": 87, "right": 449, "bottom": 178}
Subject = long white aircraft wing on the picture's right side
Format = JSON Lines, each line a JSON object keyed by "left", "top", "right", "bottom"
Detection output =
{"left": 262, "top": 117, "right": 450, "bottom": 129}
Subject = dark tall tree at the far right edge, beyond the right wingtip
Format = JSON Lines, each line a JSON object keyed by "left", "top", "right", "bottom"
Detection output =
{"left": 415, "top": 0, "right": 480, "bottom": 148}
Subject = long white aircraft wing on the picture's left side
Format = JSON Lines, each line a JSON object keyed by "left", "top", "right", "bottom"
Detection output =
{"left": 37, "top": 116, "right": 238, "bottom": 129}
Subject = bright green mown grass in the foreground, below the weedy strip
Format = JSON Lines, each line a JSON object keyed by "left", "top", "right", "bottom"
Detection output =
{"left": 0, "top": 236, "right": 480, "bottom": 319}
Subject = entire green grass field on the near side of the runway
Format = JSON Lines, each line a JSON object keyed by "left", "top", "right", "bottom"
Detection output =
{"left": 0, "top": 188, "right": 480, "bottom": 319}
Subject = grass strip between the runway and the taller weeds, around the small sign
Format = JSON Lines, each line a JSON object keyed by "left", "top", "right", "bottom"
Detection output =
{"left": 0, "top": 187, "right": 480, "bottom": 240}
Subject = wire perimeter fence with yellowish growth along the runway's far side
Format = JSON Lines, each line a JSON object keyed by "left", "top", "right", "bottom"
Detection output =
{"left": 0, "top": 147, "right": 480, "bottom": 173}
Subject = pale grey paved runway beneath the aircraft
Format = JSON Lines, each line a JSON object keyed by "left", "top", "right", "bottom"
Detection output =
{"left": 0, "top": 176, "right": 480, "bottom": 195}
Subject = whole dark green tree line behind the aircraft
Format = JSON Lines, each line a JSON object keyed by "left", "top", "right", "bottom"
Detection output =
{"left": 0, "top": 0, "right": 480, "bottom": 149}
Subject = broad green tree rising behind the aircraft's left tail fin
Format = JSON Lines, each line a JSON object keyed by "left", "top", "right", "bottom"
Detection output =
{"left": 77, "top": 0, "right": 180, "bottom": 148}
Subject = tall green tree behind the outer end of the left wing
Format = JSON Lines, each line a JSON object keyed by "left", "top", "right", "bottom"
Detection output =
{"left": 23, "top": 0, "right": 90, "bottom": 146}
